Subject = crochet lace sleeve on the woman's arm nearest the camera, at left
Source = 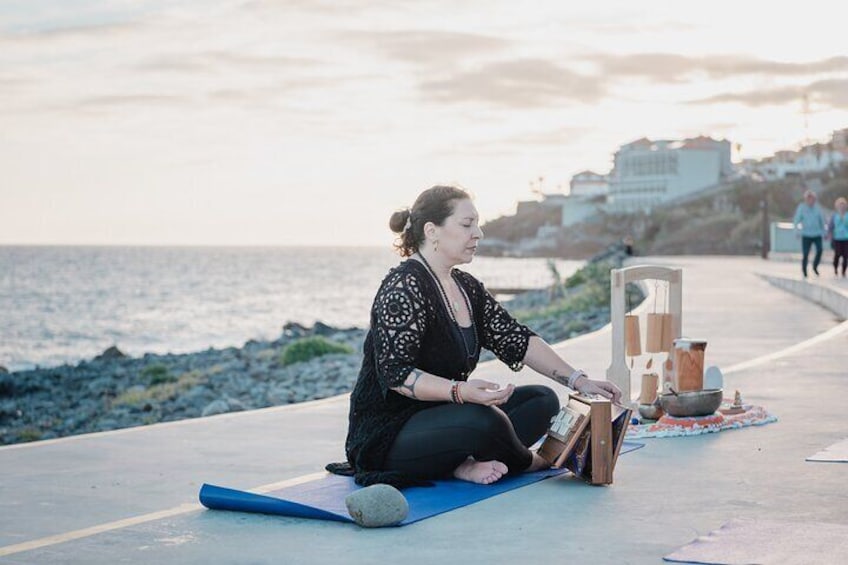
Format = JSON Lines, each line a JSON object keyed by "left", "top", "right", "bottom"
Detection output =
{"left": 371, "top": 272, "right": 427, "bottom": 396}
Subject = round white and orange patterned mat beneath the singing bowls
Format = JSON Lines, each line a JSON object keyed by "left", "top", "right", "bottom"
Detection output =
{"left": 626, "top": 404, "right": 777, "bottom": 439}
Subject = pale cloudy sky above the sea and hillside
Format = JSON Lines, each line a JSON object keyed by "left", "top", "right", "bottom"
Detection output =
{"left": 0, "top": 0, "right": 848, "bottom": 246}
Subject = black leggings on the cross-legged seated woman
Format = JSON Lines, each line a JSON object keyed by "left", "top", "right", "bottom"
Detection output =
{"left": 384, "top": 385, "right": 559, "bottom": 479}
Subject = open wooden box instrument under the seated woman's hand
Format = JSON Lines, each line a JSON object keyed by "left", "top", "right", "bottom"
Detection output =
{"left": 539, "top": 394, "right": 631, "bottom": 485}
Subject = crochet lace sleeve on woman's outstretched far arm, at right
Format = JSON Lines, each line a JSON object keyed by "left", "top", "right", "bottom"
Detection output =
{"left": 480, "top": 284, "right": 536, "bottom": 371}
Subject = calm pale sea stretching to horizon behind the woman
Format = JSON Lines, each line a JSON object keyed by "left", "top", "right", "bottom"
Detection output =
{"left": 0, "top": 246, "right": 583, "bottom": 371}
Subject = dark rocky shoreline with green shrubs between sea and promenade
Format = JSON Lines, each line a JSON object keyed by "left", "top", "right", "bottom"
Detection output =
{"left": 0, "top": 248, "right": 636, "bottom": 445}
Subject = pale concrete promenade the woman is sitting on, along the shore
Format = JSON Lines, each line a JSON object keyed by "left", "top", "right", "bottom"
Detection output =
{"left": 0, "top": 257, "right": 848, "bottom": 565}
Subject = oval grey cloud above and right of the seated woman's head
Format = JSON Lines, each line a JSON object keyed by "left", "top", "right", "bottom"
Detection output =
{"left": 419, "top": 59, "right": 604, "bottom": 108}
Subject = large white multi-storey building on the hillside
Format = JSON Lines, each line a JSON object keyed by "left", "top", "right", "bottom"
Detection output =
{"left": 607, "top": 136, "right": 733, "bottom": 212}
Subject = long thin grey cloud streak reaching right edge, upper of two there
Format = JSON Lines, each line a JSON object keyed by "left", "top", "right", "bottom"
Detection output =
{"left": 584, "top": 53, "right": 848, "bottom": 82}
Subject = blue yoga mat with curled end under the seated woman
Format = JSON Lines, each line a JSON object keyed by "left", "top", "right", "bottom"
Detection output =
{"left": 200, "top": 441, "right": 645, "bottom": 526}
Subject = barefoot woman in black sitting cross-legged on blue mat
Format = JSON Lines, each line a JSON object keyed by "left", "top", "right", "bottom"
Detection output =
{"left": 327, "top": 186, "right": 621, "bottom": 487}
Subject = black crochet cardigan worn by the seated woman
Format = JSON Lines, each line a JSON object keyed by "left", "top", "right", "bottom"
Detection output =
{"left": 328, "top": 259, "right": 535, "bottom": 487}
